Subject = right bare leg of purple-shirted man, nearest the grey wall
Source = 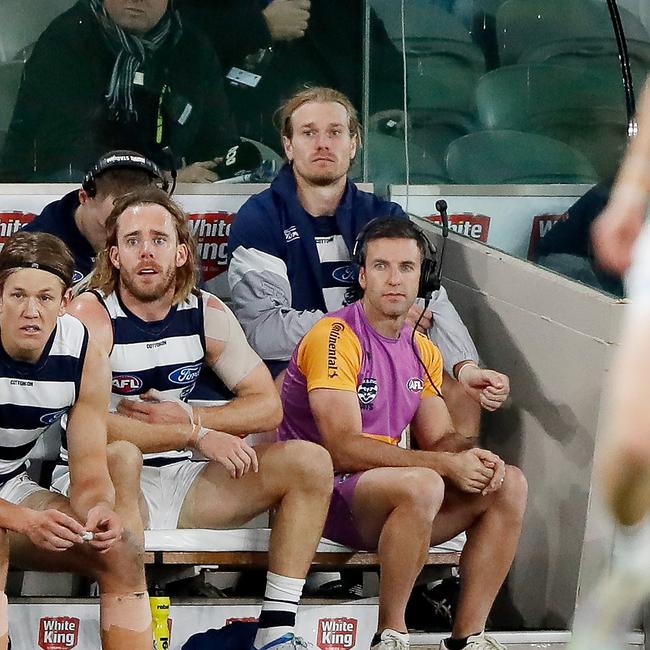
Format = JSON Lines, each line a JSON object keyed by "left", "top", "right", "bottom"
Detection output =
{"left": 431, "top": 466, "right": 527, "bottom": 638}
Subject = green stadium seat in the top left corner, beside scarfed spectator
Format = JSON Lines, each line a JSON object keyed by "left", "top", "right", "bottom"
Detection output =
{"left": 0, "top": 0, "right": 75, "bottom": 61}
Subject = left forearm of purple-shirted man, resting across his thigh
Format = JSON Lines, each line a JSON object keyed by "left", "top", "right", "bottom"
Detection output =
{"left": 329, "top": 435, "right": 449, "bottom": 476}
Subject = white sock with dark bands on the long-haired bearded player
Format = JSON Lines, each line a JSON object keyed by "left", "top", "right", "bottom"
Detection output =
{"left": 253, "top": 571, "right": 305, "bottom": 650}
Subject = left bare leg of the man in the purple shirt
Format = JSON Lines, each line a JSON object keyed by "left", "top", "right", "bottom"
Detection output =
{"left": 353, "top": 467, "right": 444, "bottom": 632}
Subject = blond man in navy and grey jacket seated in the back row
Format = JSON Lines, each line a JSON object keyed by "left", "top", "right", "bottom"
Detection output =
{"left": 228, "top": 88, "right": 509, "bottom": 437}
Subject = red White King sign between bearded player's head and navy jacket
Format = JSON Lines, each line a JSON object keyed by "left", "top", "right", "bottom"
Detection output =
{"left": 188, "top": 212, "right": 235, "bottom": 281}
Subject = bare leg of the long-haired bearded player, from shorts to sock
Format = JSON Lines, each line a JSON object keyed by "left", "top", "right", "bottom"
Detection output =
{"left": 178, "top": 440, "right": 332, "bottom": 578}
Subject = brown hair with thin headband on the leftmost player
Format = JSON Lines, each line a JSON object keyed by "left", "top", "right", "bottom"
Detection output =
{"left": 0, "top": 230, "right": 74, "bottom": 290}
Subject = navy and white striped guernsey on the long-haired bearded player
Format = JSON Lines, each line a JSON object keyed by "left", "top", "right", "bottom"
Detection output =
{"left": 87, "top": 292, "right": 205, "bottom": 465}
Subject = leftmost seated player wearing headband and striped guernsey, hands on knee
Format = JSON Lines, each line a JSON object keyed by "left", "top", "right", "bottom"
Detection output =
{"left": 0, "top": 232, "right": 152, "bottom": 650}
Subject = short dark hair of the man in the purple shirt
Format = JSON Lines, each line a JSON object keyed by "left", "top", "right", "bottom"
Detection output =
{"left": 345, "top": 217, "right": 429, "bottom": 304}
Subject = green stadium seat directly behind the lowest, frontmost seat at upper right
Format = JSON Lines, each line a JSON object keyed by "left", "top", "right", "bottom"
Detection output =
{"left": 476, "top": 63, "right": 627, "bottom": 177}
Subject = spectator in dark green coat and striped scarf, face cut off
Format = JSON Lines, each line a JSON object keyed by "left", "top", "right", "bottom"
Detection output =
{"left": 1, "top": 0, "right": 236, "bottom": 182}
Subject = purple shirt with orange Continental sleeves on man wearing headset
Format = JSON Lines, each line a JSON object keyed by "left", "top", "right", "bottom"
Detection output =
{"left": 279, "top": 301, "right": 443, "bottom": 445}
